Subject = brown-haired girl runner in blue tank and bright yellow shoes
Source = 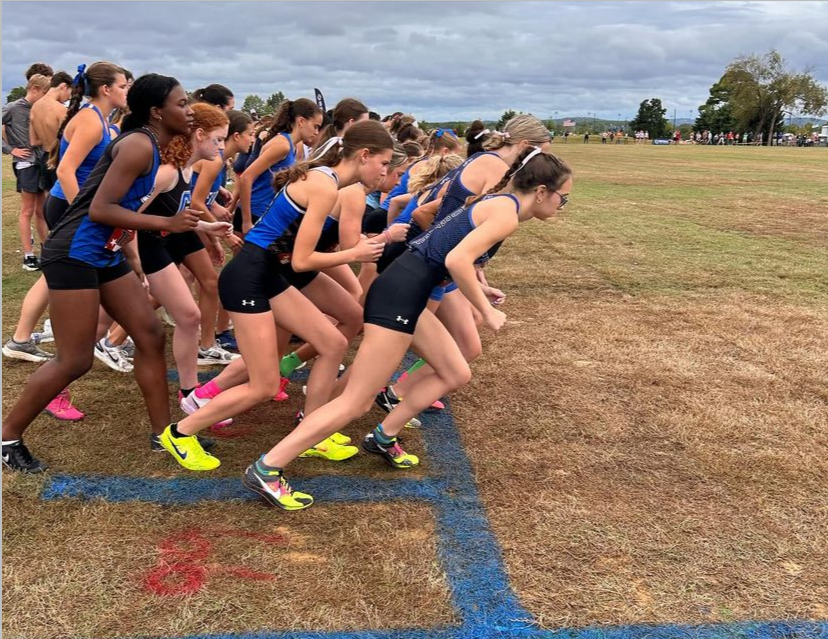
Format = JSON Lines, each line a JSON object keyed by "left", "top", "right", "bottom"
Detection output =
{"left": 159, "top": 121, "right": 393, "bottom": 510}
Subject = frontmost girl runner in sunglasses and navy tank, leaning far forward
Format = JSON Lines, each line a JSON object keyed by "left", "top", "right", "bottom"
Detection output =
{"left": 251, "top": 148, "right": 572, "bottom": 500}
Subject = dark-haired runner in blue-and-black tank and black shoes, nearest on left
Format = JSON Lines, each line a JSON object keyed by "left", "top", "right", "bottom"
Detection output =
{"left": 3, "top": 74, "right": 198, "bottom": 472}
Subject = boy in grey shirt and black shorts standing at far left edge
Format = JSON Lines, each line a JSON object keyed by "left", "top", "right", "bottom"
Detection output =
{"left": 3, "top": 74, "right": 51, "bottom": 271}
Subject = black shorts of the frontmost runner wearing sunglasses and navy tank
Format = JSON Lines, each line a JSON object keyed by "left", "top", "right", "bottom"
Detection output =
{"left": 365, "top": 251, "right": 445, "bottom": 335}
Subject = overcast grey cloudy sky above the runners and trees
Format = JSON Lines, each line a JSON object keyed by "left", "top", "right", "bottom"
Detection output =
{"left": 2, "top": 2, "right": 828, "bottom": 121}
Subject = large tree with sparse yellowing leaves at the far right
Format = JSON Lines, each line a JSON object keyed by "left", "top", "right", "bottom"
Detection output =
{"left": 722, "top": 49, "right": 828, "bottom": 141}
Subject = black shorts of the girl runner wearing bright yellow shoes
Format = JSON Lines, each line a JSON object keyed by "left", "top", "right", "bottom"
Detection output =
{"left": 219, "top": 242, "right": 290, "bottom": 314}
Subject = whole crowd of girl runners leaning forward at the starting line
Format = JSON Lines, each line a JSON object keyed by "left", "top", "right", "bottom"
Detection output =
{"left": 2, "top": 62, "right": 572, "bottom": 510}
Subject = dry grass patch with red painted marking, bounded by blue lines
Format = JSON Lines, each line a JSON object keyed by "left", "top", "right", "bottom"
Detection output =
{"left": 3, "top": 498, "right": 454, "bottom": 639}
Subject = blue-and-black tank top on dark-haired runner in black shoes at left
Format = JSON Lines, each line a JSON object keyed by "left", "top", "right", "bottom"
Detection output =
{"left": 41, "top": 128, "right": 161, "bottom": 268}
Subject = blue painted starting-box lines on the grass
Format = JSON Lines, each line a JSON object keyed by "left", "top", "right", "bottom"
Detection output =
{"left": 43, "top": 358, "right": 828, "bottom": 639}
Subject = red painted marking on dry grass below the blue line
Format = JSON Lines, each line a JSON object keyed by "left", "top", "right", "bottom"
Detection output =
{"left": 144, "top": 528, "right": 290, "bottom": 597}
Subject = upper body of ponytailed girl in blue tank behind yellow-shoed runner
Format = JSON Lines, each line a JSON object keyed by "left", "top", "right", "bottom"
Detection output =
{"left": 237, "top": 98, "right": 322, "bottom": 239}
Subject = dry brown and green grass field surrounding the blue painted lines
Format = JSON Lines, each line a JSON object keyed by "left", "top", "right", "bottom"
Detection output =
{"left": 3, "top": 142, "right": 828, "bottom": 639}
